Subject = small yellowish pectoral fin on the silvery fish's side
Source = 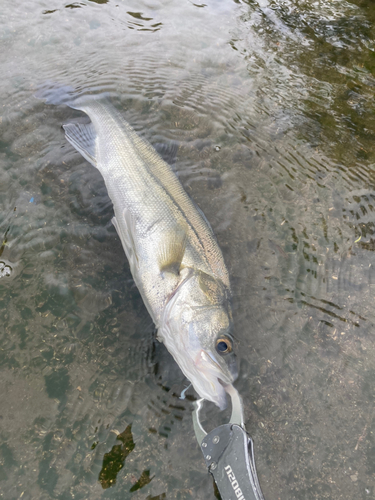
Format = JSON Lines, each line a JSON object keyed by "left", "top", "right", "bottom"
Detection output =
{"left": 158, "top": 226, "right": 187, "bottom": 275}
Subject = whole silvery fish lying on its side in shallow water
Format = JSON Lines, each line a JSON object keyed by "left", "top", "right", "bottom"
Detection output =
{"left": 38, "top": 91, "right": 238, "bottom": 409}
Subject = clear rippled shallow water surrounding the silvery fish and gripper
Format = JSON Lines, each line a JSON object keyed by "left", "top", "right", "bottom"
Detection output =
{"left": 0, "top": 0, "right": 375, "bottom": 500}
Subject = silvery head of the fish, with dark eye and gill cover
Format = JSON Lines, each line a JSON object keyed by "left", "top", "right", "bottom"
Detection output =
{"left": 159, "top": 273, "right": 238, "bottom": 409}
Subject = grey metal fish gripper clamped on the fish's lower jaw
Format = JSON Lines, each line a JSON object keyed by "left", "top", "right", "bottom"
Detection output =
{"left": 193, "top": 385, "right": 264, "bottom": 500}
